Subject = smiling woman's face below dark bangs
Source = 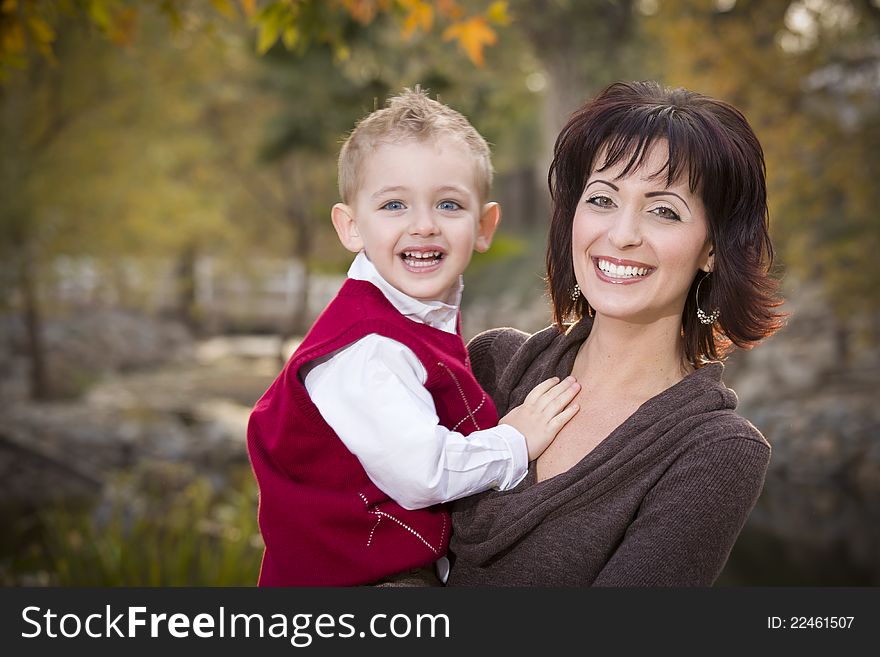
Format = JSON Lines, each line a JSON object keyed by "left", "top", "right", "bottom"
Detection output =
{"left": 572, "top": 141, "right": 712, "bottom": 324}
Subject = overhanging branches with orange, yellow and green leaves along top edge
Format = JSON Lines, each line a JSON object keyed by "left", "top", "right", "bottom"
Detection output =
{"left": 0, "top": 0, "right": 508, "bottom": 80}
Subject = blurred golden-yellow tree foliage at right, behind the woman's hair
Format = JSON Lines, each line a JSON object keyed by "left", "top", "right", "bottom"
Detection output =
{"left": 645, "top": 0, "right": 880, "bottom": 355}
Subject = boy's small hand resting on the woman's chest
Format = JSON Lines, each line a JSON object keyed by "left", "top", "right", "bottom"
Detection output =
{"left": 499, "top": 376, "right": 581, "bottom": 461}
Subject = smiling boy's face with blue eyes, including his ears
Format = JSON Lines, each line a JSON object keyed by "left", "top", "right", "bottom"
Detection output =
{"left": 332, "top": 137, "right": 500, "bottom": 301}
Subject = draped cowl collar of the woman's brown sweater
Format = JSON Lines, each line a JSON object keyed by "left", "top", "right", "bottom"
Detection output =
{"left": 451, "top": 318, "right": 736, "bottom": 563}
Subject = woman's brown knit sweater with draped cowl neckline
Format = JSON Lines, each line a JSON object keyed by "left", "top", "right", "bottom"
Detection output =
{"left": 449, "top": 320, "right": 770, "bottom": 586}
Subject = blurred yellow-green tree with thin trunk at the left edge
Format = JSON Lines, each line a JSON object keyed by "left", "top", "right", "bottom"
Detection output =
{"left": 0, "top": 11, "right": 258, "bottom": 399}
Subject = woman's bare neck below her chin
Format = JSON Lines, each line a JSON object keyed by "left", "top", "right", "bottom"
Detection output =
{"left": 572, "top": 315, "right": 693, "bottom": 399}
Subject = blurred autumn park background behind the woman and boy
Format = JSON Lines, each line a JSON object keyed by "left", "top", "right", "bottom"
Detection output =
{"left": 0, "top": 0, "right": 880, "bottom": 586}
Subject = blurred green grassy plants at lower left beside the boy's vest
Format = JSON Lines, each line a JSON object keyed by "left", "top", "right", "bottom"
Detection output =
{"left": 7, "top": 469, "right": 262, "bottom": 586}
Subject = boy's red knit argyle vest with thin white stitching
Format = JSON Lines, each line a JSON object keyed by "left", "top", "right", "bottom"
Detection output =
{"left": 248, "top": 279, "right": 498, "bottom": 586}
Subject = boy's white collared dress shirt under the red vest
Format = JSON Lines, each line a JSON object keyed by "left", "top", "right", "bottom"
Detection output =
{"left": 301, "top": 251, "right": 528, "bottom": 509}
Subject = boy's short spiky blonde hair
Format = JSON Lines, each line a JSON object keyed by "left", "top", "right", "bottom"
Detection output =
{"left": 339, "top": 87, "right": 492, "bottom": 204}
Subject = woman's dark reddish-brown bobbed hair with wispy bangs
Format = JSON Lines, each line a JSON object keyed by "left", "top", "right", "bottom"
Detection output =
{"left": 547, "top": 82, "right": 784, "bottom": 367}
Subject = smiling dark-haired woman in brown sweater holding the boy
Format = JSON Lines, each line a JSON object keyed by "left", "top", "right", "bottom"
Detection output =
{"left": 449, "top": 82, "right": 782, "bottom": 586}
